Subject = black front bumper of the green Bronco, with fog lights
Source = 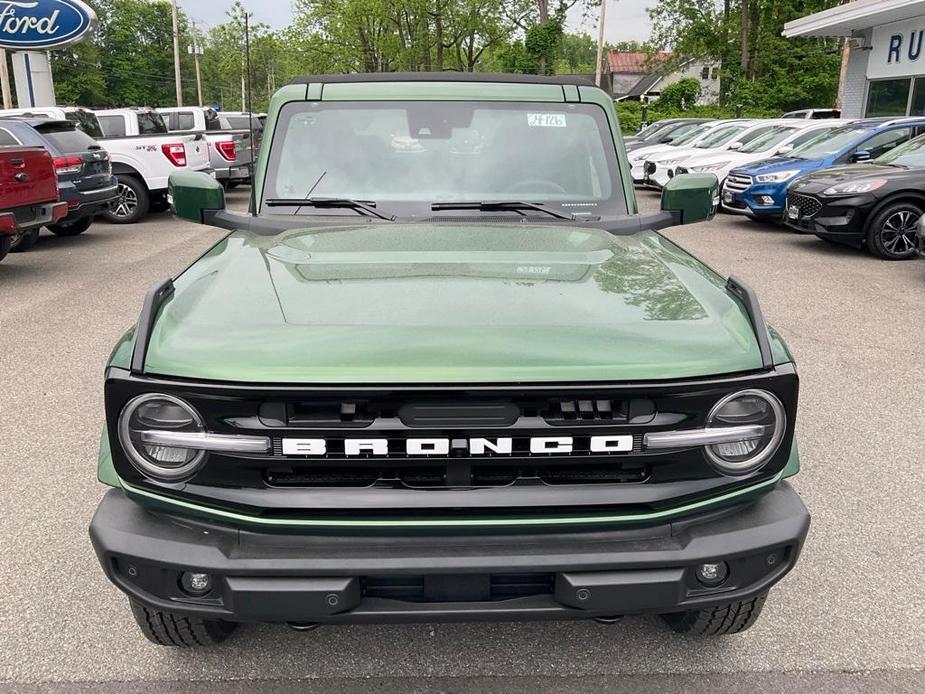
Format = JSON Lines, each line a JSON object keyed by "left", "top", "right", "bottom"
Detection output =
{"left": 90, "top": 482, "right": 809, "bottom": 623}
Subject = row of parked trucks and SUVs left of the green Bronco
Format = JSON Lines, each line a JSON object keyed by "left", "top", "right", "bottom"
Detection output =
{"left": 0, "top": 107, "right": 265, "bottom": 264}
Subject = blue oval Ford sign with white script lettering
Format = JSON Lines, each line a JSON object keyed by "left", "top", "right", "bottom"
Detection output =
{"left": 0, "top": 0, "right": 96, "bottom": 51}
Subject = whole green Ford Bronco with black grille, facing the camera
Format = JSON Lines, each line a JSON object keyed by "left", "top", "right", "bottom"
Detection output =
{"left": 90, "top": 73, "right": 809, "bottom": 646}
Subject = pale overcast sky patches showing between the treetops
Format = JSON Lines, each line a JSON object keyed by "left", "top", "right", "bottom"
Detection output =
{"left": 178, "top": 0, "right": 657, "bottom": 43}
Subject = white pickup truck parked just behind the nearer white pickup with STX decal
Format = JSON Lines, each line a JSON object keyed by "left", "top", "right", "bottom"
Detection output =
{"left": 157, "top": 106, "right": 253, "bottom": 188}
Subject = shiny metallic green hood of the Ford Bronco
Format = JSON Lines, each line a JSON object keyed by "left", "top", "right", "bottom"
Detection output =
{"left": 145, "top": 223, "right": 786, "bottom": 384}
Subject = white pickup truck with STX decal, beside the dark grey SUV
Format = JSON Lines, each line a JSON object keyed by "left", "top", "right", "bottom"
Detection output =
{"left": 95, "top": 108, "right": 212, "bottom": 224}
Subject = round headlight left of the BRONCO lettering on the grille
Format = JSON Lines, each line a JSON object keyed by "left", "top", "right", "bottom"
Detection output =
{"left": 119, "top": 393, "right": 205, "bottom": 482}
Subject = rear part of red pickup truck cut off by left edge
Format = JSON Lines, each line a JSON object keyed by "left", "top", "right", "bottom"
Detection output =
{"left": 0, "top": 147, "right": 67, "bottom": 260}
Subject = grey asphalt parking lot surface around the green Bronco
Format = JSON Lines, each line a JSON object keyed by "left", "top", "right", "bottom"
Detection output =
{"left": 0, "top": 189, "right": 925, "bottom": 693}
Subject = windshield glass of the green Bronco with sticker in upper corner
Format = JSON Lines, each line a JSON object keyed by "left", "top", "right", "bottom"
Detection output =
{"left": 264, "top": 101, "right": 626, "bottom": 216}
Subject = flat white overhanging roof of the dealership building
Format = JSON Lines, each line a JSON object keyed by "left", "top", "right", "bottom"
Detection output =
{"left": 781, "top": 0, "right": 925, "bottom": 38}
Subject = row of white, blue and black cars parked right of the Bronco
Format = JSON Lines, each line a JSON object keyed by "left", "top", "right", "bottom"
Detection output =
{"left": 629, "top": 117, "right": 925, "bottom": 260}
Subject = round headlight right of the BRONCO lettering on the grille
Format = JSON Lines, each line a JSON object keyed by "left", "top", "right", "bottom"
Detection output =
{"left": 704, "top": 390, "right": 787, "bottom": 475}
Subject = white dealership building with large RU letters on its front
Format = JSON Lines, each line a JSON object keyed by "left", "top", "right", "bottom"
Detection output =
{"left": 783, "top": 0, "right": 925, "bottom": 118}
